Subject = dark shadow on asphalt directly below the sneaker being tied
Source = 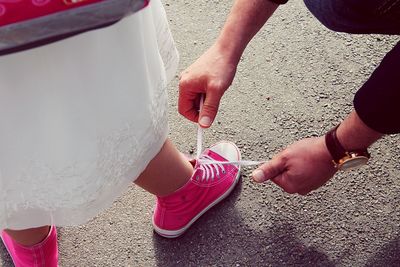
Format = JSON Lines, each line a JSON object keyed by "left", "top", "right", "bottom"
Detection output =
{"left": 153, "top": 180, "right": 334, "bottom": 267}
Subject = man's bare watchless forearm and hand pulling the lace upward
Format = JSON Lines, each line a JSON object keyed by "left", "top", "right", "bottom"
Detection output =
{"left": 178, "top": 0, "right": 285, "bottom": 127}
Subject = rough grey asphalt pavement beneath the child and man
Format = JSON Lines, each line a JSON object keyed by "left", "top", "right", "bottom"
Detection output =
{"left": 0, "top": 0, "right": 400, "bottom": 267}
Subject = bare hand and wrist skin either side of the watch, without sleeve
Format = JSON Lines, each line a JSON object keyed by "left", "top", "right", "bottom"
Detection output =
{"left": 252, "top": 111, "right": 382, "bottom": 195}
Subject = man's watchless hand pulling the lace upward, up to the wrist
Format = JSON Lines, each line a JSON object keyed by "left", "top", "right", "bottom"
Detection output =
{"left": 178, "top": 44, "right": 237, "bottom": 128}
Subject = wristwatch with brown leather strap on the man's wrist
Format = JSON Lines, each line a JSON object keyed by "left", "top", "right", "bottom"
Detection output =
{"left": 325, "top": 125, "right": 370, "bottom": 171}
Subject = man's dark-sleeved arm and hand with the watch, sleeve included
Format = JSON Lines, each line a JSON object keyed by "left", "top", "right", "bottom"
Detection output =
{"left": 253, "top": 43, "right": 400, "bottom": 194}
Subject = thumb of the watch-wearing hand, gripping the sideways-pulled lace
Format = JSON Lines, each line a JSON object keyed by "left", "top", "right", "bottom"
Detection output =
{"left": 252, "top": 157, "right": 286, "bottom": 183}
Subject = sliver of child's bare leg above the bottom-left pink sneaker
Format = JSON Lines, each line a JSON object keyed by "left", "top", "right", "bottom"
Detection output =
{"left": 5, "top": 226, "right": 50, "bottom": 246}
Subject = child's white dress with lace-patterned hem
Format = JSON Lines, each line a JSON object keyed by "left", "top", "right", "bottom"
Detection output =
{"left": 0, "top": 0, "right": 178, "bottom": 229}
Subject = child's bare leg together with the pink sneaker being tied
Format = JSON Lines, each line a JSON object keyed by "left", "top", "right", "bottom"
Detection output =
{"left": 135, "top": 140, "right": 240, "bottom": 238}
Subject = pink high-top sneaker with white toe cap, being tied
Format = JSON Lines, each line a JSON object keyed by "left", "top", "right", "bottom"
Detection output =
{"left": 153, "top": 142, "right": 241, "bottom": 238}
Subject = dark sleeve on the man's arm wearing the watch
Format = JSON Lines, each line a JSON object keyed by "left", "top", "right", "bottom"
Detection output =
{"left": 354, "top": 42, "right": 400, "bottom": 134}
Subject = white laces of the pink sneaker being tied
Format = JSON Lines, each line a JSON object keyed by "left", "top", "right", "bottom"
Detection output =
{"left": 196, "top": 96, "right": 264, "bottom": 173}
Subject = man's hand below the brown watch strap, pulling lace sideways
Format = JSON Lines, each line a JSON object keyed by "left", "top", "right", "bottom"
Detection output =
{"left": 253, "top": 137, "right": 337, "bottom": 195}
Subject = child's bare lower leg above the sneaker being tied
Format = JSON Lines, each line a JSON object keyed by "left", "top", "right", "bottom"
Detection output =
{"left": 135, "top": 140, "right": 193, "bottom": 196}
